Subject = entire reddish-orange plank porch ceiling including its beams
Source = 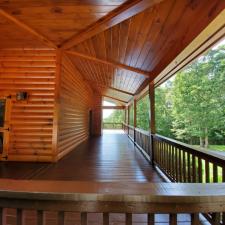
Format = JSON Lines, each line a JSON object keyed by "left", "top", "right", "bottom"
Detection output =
{"left": 0, "top": 0, "right": 225, "bottom": 102}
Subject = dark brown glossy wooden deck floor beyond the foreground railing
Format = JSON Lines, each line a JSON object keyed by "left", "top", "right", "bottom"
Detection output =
{"left": 0, "top": 133, "right": 163, "bottom": 182}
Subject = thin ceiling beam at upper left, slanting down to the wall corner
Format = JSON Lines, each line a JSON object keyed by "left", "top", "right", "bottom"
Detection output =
{"left": 0, "top": 9, "right": 58, "bottom": 49}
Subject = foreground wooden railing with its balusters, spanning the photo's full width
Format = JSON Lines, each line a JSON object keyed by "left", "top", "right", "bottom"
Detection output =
{"left": 0, "top": 180, "right": 225, "bottom": 225}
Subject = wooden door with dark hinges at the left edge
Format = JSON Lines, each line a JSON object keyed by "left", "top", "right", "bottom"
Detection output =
{"left": 0, "top": 97, "right": 11, "bottom": 160}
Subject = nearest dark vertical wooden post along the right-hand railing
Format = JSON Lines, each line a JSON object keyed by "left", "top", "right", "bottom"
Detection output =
{"left": 149, "top": 82, "right": 156, "bottom": 165}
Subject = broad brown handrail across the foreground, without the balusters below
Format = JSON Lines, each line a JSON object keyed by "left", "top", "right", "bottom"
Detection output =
{"left": 0, "top": 179, "right": 225, "bottom": 209}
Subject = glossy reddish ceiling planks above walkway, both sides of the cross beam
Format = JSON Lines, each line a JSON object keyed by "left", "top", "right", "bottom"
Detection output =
{"left": 69, "top": 0, "right": 225, "bottom": 99}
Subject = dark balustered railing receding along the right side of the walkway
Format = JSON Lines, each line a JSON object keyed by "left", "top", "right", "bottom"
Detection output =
{"left": 123, "top": 124, "right": 225, "bottom": 224}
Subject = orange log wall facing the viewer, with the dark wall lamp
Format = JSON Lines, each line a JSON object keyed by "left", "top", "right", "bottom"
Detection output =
{"left": 0, "top": 49, "right": 56, "bottom": 161}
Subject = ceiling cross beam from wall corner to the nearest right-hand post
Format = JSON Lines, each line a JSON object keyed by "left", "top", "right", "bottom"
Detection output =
{"left": 66, "top": 51, "right": 150, "bottom": 77}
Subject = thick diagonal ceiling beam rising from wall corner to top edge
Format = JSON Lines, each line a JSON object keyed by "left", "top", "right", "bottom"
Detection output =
{"left": 60, "top": 0, "right": 163, "bottom": 49}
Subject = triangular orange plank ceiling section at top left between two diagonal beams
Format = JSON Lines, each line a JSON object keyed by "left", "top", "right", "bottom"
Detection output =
{"left": 0, "top": 0, "right": 125, "bottom": 45}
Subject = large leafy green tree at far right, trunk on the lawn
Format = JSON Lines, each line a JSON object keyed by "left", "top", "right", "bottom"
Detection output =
{"left": 172, "top": 46, "right": 225, "bottom": 148}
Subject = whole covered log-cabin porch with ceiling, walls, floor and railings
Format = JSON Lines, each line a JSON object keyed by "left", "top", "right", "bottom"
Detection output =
{"left": 0, "top": 0, "right": 225, "bottom": 225}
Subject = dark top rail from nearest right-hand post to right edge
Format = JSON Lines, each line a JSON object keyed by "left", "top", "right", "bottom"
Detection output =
{"left": 153, "top": 134, "right": 225, "bottom": 166}
